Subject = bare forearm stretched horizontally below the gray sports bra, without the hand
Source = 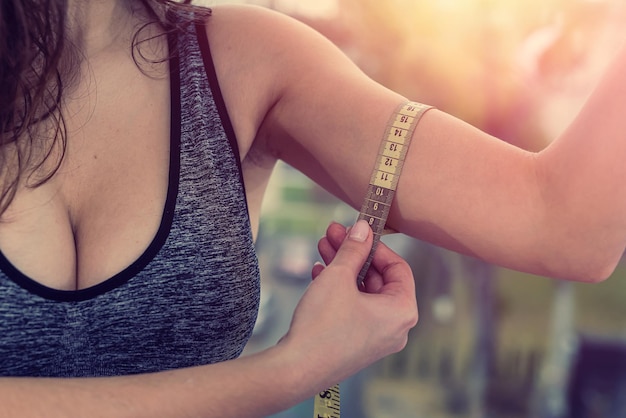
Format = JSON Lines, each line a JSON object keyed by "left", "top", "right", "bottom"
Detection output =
{"left": 0, "top": 347, "right": 315, "bottom": 418}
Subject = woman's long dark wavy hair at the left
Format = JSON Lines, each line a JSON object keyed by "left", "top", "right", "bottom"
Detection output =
{"left": 0, "top": 0, "right": 210, "bottom": 216}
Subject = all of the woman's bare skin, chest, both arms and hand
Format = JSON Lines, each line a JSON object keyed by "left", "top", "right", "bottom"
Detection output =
{"left": 0, "top": 0, "right": 626, "bottom": 417}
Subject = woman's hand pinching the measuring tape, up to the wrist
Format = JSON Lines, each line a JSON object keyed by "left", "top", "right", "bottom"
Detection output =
{"left": 280, "top": 221, "right": 418, "bottom": 390}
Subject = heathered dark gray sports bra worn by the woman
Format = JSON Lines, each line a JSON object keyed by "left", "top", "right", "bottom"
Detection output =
{"left": 0, "top": 12, "right": 259, "bottom": 377}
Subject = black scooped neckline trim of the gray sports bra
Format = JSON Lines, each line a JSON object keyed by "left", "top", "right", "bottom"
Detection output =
{"left": 0, "top": 31, "right": 181, "bottom": 302}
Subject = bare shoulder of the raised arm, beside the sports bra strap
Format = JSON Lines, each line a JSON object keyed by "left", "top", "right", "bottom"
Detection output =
{"left": 199, "top": 5, "right": 348, "bottom": 157}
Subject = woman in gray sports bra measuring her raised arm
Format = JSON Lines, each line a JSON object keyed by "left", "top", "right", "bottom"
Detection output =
{"left": 0, "top": 0, "right": 626, "bottom": 417}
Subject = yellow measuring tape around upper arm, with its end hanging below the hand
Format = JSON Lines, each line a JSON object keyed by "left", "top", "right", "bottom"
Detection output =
{"left": 313, "top": 102, "right": 432, "bottom": 418}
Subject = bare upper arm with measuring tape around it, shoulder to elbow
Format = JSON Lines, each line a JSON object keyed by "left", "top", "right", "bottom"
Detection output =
{"left": 208, "top": 4, "right": 616, "bottom": 275}
